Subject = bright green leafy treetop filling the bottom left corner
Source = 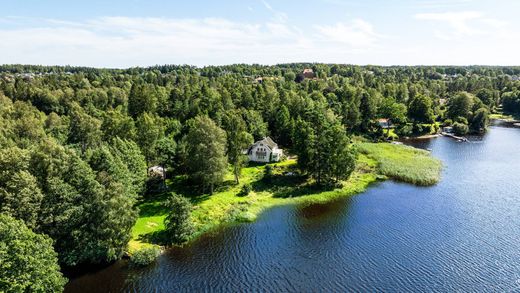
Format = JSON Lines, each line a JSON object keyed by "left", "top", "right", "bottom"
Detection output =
{"left": 0, "top": 214, "right": 67, "bottom": 292}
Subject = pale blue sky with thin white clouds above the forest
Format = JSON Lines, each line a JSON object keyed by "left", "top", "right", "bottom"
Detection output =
{"left": 0, "top": 0, "right": 520, "bottom": 68}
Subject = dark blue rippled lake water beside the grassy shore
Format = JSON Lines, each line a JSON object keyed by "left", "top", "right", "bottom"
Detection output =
{"left": 66, "top": 127, "right": 520, "bottom": 292}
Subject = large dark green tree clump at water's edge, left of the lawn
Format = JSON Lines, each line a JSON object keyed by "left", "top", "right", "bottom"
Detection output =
{"left": 31, "top": 143, "right": 136, "bottom": 265}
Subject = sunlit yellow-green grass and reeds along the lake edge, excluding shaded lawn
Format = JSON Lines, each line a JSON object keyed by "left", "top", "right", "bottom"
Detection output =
{"left": 128, "top": 143, "right": 442, "bottom": 255}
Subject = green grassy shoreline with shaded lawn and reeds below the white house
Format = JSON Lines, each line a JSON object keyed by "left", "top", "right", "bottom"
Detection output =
{"left": 128, "top": 143, "right": 442, "bottom": 254}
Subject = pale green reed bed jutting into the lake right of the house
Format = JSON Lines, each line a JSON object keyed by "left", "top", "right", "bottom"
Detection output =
{"left": 358, "top": 143, "right": 442, "bottom": 186}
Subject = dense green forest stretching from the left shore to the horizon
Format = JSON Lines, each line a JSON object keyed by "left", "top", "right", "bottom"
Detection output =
{"left": 0, "top": 64, "right": 520, "bottom": 291}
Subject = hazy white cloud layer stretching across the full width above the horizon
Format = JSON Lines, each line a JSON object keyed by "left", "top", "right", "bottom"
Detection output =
{"left": 0, "top": 13, "right": 520, "bottom": 67}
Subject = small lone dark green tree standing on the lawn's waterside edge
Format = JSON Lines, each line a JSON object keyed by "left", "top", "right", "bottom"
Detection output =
{"left": 164, "top": 193, "right": 194, "bottom": 244}
